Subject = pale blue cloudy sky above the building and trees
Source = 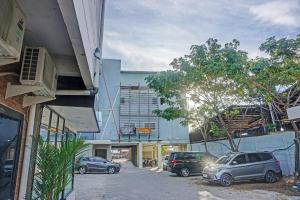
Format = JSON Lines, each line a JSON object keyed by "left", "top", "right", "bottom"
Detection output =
{"left": 103, "top": 0, "right": 300, "bottom": 71}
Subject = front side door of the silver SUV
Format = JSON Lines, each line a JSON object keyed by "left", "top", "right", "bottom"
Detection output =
{"left": 229, "top": 154, "right": 248, "bottom": 180}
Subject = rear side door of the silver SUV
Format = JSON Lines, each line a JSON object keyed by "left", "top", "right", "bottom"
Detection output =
{"left": 247, "top": 153, "right": 264, "bottom": 179}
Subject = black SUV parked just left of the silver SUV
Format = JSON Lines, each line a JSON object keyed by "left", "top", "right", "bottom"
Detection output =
{"left": 167, "top": 152, "right": 217, "bottom": 177}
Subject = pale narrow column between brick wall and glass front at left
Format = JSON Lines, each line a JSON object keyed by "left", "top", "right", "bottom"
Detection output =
{"left": 19, "top": 105, "right": 36, "bottom": 199}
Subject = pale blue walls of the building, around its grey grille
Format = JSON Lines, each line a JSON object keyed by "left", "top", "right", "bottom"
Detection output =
{"left": 96, "top": 59, "right": 189, "bottom": 144}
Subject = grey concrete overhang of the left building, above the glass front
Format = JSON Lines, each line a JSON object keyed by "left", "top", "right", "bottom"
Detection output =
{"left": 17, "top": 0, "right": 101, "bottom": 132}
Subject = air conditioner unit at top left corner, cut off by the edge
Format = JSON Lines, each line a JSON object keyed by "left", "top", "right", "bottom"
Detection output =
{"left": 0, "top": 0, "right": 25, "bottom": 66}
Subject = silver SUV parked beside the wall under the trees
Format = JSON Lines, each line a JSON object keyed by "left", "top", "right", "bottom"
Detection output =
{"left": 202, "top": 152, "right": 282, "bottom": 186}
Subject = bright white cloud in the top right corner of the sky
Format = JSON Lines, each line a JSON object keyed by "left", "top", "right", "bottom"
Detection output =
{"left": 249, "top": 0, "right": 300, "bottom": 27}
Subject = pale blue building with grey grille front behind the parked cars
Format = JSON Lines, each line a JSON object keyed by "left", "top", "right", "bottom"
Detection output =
{"left": 81, "top": 59, "right": 189, "bottom": 167}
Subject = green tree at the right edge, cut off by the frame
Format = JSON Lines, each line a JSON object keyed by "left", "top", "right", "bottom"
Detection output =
{"left": 244, "top": 35, "right": 300, "bottom": 117}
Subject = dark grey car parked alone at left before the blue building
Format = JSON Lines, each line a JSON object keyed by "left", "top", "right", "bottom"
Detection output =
{"left": 75, "top": 157, "right": 121, "bottom": 174}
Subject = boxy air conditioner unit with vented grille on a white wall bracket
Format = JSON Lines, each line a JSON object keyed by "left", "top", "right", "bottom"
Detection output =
{"left": 20, "top": 47, "right": 57, "bottom": 97}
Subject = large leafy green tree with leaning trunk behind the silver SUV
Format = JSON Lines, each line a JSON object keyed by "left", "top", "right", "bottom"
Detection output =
{"left": 146, "top": 39, "right": 249, "bottom": 151}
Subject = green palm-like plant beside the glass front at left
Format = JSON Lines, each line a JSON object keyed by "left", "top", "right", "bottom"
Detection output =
{"left": 27, "top": 137, "right": 88, "bottom": 200}
